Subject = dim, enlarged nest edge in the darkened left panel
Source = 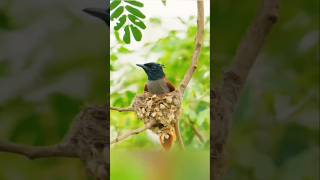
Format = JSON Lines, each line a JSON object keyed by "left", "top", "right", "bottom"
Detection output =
{"left": 64, "top": 106, "right": 110, "bottom": 180}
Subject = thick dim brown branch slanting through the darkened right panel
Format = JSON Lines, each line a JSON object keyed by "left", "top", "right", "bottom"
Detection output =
{"left": 211, "top": 0, "right": 279, "bottom": 180}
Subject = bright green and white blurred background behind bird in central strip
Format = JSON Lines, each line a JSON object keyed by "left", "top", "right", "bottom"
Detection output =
{"left": 110, "top": 0, "right": 210, "bottom": 180}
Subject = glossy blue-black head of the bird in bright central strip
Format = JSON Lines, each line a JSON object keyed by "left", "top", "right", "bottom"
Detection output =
{"left": 137, "top": 62, "right": 165, "bottom": 81}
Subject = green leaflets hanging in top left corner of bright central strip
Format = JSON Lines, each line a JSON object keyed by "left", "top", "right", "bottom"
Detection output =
{"left": 110, "top": 0, "right": 146, "bottom": 44}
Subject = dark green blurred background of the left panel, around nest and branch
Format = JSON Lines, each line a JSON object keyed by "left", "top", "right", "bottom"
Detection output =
{"left": 0, "top": 0, "right": 107, "bottom": 180}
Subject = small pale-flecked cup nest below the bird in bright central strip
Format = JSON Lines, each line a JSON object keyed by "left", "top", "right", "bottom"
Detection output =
{"left": 133, "top": 90, "right": 182, "bottom": 135}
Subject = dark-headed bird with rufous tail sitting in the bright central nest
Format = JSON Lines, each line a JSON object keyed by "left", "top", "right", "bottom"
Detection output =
{"left": 136, "top": 62, "right": 177, "bottom": 151}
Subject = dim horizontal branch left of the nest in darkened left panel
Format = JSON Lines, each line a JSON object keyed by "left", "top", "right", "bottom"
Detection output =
{"left": 0, "top": 141, "right": 78, "bottom": 159}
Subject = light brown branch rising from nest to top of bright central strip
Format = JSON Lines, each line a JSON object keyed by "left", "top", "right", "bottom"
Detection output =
{"left": 180, "top": 0, "right": 204, "bottom": 94}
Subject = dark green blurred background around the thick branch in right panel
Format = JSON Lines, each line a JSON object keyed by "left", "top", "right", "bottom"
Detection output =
{"left": 211, "top": 0, "right": 320, "bottom": 180}
